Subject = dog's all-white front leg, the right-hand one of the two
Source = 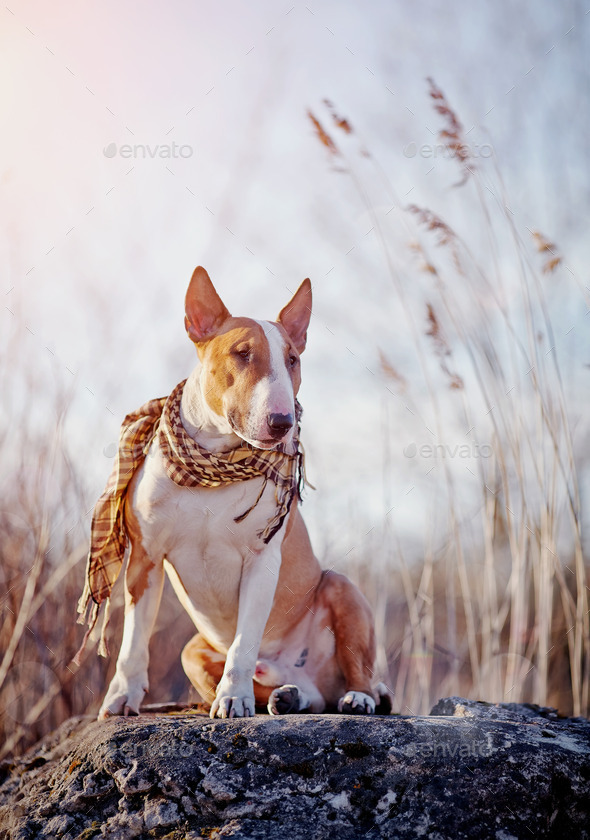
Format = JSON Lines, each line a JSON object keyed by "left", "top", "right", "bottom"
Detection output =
{"left": 211, "top": 548, "right": 282, "bottom": 718}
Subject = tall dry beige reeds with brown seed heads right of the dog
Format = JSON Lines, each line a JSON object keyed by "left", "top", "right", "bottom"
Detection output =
{"left": 313, "top": 80, "right": 590, "bottom": 715}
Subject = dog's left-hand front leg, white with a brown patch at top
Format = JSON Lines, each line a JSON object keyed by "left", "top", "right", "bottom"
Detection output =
{"left": 98, "top": 548, "right": 164, "bottom": 719}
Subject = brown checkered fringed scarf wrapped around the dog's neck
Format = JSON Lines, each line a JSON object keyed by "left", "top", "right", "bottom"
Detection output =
{"left": 74, "top": 380, "right": 305, "bottom": 662}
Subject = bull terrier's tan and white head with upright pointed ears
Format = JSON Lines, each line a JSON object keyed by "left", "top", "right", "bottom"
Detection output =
{"left": 184, "top": 266, "right": 311, "bottom": 449}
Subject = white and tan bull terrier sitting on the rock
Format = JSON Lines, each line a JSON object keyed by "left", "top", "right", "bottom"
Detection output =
{"left": 86, "top": 266, "right": 389, "bottom": 718}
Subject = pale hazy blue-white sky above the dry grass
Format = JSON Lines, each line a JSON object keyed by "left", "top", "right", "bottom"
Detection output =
{"left": 0, "top": 0, "right": 590, "bottom": 564}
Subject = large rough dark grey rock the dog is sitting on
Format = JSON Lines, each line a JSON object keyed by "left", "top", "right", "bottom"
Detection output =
{"left": 0, "top": 697, "right": 590, "bottom": 840}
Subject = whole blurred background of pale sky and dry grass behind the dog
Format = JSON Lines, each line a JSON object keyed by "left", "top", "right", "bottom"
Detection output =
{"left": 0, "top": 0, "right": 590, "bottom": 753}
